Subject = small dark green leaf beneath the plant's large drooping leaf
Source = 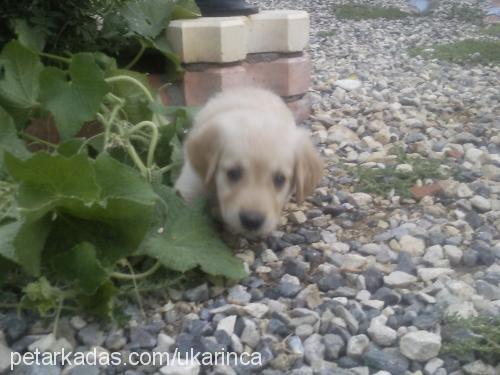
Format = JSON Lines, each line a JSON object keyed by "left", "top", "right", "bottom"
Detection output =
{"left": 53, "top": 242, "right": 109, "bottom": 295}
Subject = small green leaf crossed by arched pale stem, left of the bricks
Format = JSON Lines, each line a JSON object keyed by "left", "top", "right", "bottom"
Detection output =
{"left": 111, "top": 69, "right": 154, "bottom": 123}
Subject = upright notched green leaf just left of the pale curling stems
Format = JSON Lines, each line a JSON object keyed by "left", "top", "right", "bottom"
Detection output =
{"left": 40, "top": 53, "right": 110, "bottom": 139}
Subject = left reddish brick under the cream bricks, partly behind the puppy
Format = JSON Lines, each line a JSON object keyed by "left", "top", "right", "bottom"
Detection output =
{"left": 183, "top": 65, "right": 248, "bottom": 107}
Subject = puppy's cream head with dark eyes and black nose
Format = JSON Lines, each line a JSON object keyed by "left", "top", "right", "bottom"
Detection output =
{"left": 186, "top": 113, "right": 322, "bottom": 236}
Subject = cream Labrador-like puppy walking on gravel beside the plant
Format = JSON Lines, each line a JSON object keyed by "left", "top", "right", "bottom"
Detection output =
{"left": 175, "top": 87, "right": 322, "bottom": 237}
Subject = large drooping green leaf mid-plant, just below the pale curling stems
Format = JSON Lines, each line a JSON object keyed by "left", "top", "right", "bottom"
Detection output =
{"left": 6, "top": 153, "right": 157, "bottom": 265}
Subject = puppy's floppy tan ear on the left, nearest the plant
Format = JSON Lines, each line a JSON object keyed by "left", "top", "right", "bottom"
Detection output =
{"left": 186, "top": 126, "right": 221, "bottom": 185}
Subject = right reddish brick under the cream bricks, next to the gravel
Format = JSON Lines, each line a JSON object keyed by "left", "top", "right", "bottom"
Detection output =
{"left": 243, "top": 54, "right": 311, "bottom": 96}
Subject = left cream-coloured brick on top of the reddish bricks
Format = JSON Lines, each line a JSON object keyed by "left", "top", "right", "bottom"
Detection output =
{"left": 167, "top": 17, "right": 248, "bottom": 63}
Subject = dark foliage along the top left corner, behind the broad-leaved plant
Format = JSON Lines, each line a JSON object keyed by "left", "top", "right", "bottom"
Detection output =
{"left": 0, "top": 0, "right": 200, "bottom": 74}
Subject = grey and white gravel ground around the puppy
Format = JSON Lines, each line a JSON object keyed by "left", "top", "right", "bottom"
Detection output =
{"left": 0, "top": 0, "right": 500, "bottom": 375}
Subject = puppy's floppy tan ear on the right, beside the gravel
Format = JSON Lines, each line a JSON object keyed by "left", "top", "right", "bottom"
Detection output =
{"left": 294, "top": 129, "right": 323, "bottom": 203}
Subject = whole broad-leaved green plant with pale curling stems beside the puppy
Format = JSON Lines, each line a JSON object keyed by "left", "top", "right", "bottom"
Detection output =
{"left": 0, "top": 41, "right": 246, "bottom": 316}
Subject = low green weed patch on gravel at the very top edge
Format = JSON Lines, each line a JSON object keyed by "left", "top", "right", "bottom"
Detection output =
{"left": 333, "top": 4, "right": 408, "bottom": 21}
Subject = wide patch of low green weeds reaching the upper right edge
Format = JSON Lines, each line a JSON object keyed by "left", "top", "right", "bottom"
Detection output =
{"left": 408, "top": 39, "right": 500, "bottom": 65}
